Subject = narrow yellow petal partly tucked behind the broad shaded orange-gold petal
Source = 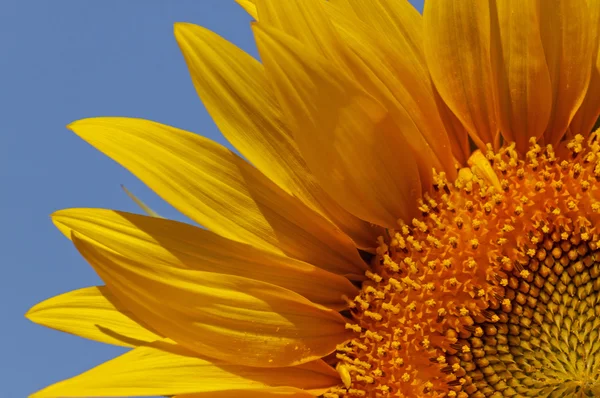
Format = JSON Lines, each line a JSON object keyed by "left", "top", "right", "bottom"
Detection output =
{"left": 175, "top": 24, "right": 379, "bottom": 247}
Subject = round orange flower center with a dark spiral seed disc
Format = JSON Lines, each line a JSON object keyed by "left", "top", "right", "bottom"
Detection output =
{"left": 325, "top": 133, "right": 600, "bottom": 397}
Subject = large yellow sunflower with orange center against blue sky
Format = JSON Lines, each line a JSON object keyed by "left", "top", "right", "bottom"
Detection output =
{"left": 27, "top": 0, "right": 600, "bottom": 398}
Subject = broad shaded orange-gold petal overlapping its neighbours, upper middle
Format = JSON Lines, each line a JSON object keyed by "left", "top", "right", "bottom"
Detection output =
{"left": 253, "top": 23, "right": 421, "bottom": 227}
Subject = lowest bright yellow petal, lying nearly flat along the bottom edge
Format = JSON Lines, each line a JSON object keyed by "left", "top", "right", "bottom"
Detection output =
{"left": 30, "top": 345, "right": 339, "bottom": 398}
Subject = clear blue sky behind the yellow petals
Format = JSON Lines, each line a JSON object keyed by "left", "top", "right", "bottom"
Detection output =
{"left": 0, "top": 0, "right": 422, "bottom": 398}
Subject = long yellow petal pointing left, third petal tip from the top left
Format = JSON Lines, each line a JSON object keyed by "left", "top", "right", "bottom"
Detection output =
{"left": 69, "top": 118, "right": 364, "bottom": 272}
